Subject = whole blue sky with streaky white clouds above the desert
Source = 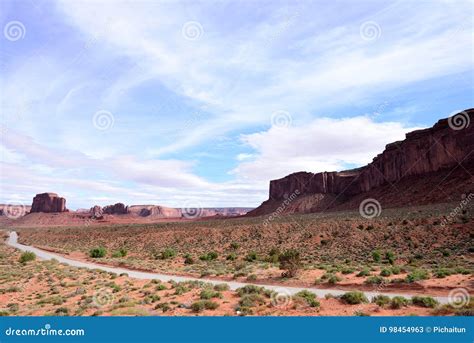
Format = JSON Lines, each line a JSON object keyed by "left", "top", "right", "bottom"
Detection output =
{"left": 0, "top": 0, "right": 474, "bottom": 209}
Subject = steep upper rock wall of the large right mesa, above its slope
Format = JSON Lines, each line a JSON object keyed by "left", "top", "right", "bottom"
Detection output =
{"left": 257, "top": 109, "right": 474, "bottom": 214}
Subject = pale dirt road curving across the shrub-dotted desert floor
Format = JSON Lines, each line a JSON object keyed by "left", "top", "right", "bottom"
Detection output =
{"left": 6, "top": 231, "right": 448, "bottom": 304}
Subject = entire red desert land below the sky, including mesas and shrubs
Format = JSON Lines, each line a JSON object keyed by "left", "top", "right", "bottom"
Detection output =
{"left": 0, "top": 109, "right": 474, "bottom": 316}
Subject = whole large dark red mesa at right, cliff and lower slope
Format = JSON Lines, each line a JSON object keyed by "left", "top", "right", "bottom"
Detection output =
{"left": 249, "top": 109, "right": 474, "bottom": 215}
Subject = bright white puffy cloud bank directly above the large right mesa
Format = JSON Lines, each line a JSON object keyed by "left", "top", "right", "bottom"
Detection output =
{"left": 233, "top": 117, "right": 417, "bottom": 180}
